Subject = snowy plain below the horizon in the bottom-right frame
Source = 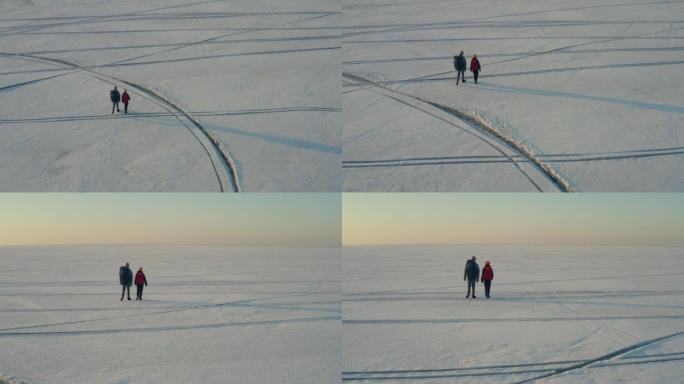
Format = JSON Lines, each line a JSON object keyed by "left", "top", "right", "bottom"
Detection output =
{"left": 342, "top": 246, "right": 684, "bottom": 384}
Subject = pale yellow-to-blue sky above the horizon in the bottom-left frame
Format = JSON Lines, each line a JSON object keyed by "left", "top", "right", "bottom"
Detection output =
{"left": 0, "top": 193, "right": 341, "bottom": 246}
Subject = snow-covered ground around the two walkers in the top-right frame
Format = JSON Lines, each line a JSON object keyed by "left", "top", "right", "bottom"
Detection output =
{"left": 342, "top": 0, "right": 684, "bottom": 192}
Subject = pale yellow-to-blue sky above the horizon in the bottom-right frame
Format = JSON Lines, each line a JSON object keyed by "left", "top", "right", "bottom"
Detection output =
{"left": 342, "top": 193, "right": 684, "bottom": 246}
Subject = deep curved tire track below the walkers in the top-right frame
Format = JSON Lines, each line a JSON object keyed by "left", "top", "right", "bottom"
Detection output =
{"left": 342, "top": 72, "right": 576, "bottom": 192}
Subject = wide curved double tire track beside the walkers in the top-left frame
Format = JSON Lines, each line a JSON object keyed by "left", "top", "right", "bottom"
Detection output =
{"left": 0, "top": 53, "right": 241, "bottom": 192}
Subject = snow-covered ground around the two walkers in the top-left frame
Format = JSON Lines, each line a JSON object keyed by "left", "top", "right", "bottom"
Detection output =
{"left": 0, "top": 0, "right": 342, "bottom": 192}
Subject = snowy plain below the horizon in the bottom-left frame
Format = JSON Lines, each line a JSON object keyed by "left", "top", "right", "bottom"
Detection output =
{"left": 0, "top": 246, "right": 341, "bottom": 384}
